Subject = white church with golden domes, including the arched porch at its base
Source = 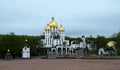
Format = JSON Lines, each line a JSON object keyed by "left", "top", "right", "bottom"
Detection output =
{"left": 41, "top": 17, "right": 71, "bottom": 54}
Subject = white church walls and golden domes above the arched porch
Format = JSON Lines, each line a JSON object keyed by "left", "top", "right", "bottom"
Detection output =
{"left": 42, "top": 17, "right": 69, "bottom": 48}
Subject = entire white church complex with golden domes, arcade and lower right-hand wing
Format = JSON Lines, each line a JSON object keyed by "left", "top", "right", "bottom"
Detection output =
{"left": 41, "top": 17, "right": 95, "bottom": 55}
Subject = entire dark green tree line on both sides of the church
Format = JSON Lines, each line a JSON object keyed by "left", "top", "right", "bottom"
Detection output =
{"left": 0, "top": 32, "right": 120, "bottom": 58}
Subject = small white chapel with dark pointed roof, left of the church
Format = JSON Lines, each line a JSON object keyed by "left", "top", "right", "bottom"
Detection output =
{"left": 22, "top": 40, "right": 30, "bottom": 58}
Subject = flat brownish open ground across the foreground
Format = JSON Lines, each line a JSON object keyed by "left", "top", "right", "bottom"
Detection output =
{"left": 0, "top": 59, "right": 120, "bottom": 70}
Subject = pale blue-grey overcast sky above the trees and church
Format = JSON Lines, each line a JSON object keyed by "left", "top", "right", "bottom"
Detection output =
{"left": 0, "top": 0, "right": 120, "bottom": 37}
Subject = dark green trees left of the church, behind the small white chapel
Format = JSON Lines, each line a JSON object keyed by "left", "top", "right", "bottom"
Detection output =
{"left": 0, "top": 34, "right": 40, "bottom": 58}
